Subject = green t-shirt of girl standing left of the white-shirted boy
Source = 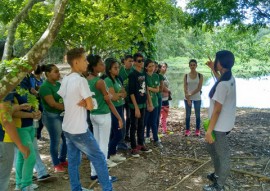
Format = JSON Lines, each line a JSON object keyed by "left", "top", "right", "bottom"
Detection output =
{"left": 39, "top": 80, "right": 63, "bottom": 113}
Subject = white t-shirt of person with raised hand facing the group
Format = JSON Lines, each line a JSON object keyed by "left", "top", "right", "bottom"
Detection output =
{"left": 208, "top": 76, "right": 236, "bottom": 132}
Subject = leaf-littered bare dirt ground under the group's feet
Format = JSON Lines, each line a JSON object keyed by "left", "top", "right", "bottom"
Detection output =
{"left": 8, "top": 108, "right": 270, "bottom": 191}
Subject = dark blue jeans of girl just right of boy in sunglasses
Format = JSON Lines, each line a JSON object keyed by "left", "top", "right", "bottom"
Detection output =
{"left": 144, "top": 107, "right": 158, "bottom": 142}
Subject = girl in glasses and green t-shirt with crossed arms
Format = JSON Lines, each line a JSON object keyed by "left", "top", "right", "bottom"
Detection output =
{"left": 104, "top": 58, "right": 127, "bottom": 162}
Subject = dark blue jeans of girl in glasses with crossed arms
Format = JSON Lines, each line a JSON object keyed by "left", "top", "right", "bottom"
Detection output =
{"left": 108, "top": 106, "right": 124, "bottom": 156}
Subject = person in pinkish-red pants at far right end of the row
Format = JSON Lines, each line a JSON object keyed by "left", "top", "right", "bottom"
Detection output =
{"left": 160, "top": 63, "right": 171, "bottom": 134}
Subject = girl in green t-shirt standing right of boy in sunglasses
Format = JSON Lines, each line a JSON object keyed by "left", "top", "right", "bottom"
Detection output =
{"left": 144, "top": 60, "right": 163, "bottom": 148}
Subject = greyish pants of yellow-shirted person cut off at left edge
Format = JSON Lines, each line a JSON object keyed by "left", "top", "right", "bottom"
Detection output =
{"left": 0, "top": 142, "right": 15, "bottom": 191}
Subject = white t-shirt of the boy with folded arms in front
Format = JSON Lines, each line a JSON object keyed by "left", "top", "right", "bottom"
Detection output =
{"left": 57, "top": 73, "right": 92, "bottom": 134}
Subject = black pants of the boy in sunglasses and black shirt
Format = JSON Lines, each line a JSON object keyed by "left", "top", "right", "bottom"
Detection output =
{"left": 130, "top": 108, "right": 145, "bottom": 149}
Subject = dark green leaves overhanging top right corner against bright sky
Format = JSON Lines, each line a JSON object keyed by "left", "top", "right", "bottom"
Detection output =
{"left": 187, "top": 0, "right": 270, "bottom": 30}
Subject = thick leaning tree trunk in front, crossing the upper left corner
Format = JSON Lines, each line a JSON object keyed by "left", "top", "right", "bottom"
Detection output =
{"left": 0, "top": 0, "right": 68, "bottom": 100}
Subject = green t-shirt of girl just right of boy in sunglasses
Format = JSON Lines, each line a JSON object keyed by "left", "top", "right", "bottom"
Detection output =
{"left": 146, "top": 73, "right": 160, "bottom": 107}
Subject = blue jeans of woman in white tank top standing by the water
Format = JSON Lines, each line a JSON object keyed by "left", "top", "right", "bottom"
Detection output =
{"left": 184, "top": 100, "right": 201, "bottom": 130}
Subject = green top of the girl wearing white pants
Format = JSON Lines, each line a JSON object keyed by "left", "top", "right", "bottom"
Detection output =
{"left": 88, "top": 77, "right": 111, "bottom": 115}
